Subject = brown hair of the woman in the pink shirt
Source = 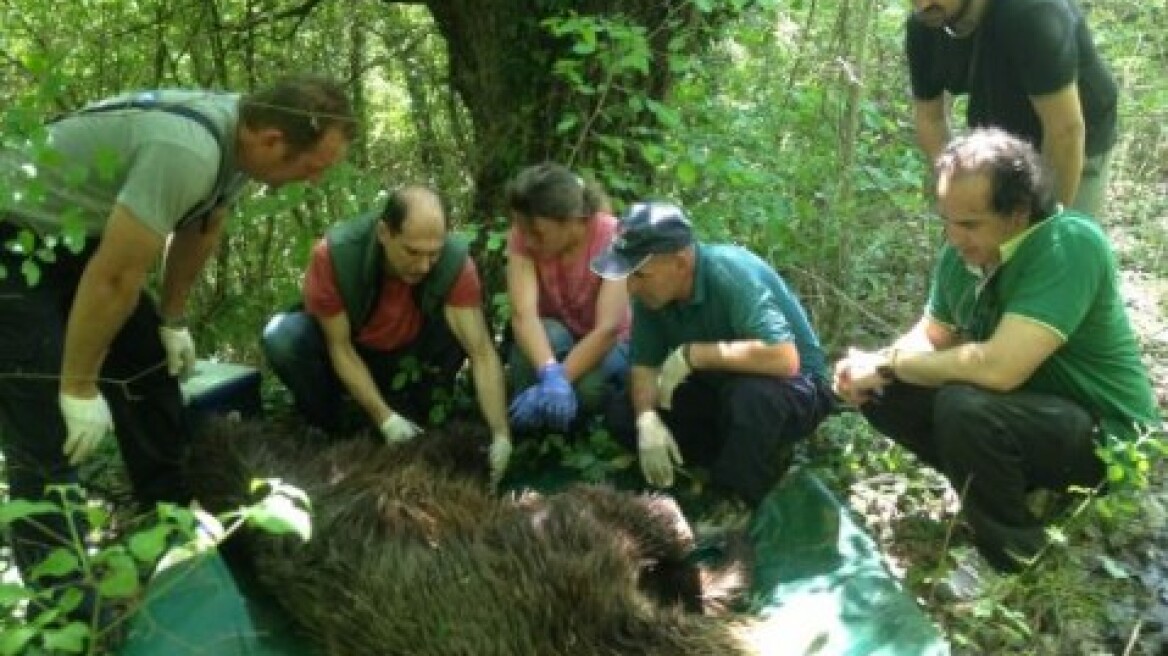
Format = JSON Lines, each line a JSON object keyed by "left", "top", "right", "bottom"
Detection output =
{"left": 507, "top": 162, "right": 610, "bottom": 223}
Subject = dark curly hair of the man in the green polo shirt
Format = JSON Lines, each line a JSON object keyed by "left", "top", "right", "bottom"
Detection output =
{"left": 934, "top": 127, "right": 1057, "bottom": 224}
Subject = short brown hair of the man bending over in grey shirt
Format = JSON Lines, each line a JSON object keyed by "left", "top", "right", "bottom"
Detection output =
{"left": 239, "top": 75, "right": 357, "bottom": 153}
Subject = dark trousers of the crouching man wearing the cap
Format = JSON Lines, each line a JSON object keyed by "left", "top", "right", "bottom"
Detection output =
{"left": 609, "top": 372, "right": 835, "bottom": 505}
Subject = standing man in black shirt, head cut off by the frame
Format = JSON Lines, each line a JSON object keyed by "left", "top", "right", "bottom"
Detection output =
{"left": 905, "top": 0, "right": 1117, "bottom": 217}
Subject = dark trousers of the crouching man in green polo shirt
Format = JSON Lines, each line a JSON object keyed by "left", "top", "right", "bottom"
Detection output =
{"left": 861, "top": 383, "right": 1105, "bottom": 571}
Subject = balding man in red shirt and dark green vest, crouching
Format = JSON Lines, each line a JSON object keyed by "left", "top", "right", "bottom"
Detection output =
{"left": 263, "top": 187, "right": 510, "bottom": 479}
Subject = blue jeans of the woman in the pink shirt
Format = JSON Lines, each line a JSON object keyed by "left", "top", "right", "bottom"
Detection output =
{"left": 507, "top": 319, "right": 628, "bottom": 416}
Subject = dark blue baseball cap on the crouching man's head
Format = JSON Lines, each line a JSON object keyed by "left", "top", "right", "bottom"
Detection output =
{"left": 591, "top": 202, "right": 694, "bottom": 280}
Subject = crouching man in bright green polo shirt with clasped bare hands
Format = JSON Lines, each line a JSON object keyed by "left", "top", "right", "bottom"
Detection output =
{"left": 835, "top": 128, "right": 1160, "bottom": 594}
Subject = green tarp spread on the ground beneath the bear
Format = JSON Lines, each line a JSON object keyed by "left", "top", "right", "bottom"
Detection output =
{"left": 121, "top": 470, "right": 948, "bottom": 656}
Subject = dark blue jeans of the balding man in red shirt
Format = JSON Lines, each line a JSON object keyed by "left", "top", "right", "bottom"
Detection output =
{"left": 260, "top": 310, "right": 466, "bottom": 434}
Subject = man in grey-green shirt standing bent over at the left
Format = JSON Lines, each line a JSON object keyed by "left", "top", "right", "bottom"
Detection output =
{"left": 0, "top": 77, "right": 355, "bottom": 623}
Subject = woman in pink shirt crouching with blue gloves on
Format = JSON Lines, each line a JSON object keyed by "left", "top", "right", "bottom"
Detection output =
{"left": 507, "top": 162, "right": 631, "bottom": 431}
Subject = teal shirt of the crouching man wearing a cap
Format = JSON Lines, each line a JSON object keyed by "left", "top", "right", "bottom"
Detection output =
{"left": 632, "top": 244, "right": 827, "bottom": 378}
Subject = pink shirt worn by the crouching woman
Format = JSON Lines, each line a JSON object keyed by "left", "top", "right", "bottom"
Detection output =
{"left": 507, "top": 214, "right": 632, "bottom": 339}
